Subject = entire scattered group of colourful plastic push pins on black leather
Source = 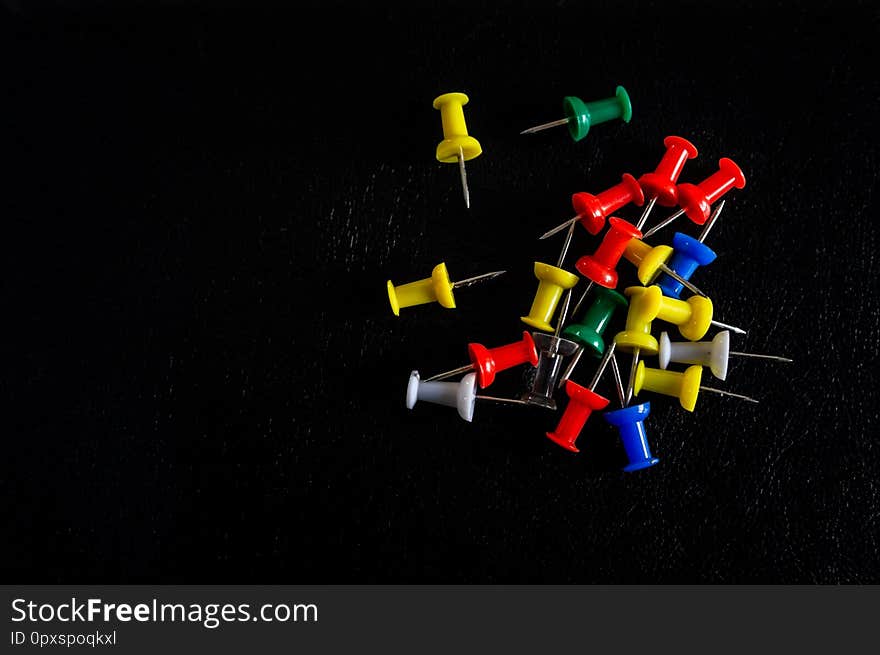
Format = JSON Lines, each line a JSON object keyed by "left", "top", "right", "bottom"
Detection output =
{"left": 388, "top": 86, "right": 791, "bottom": 471}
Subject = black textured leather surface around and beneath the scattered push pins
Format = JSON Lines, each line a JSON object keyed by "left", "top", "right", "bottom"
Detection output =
{"left": 0, "top": 0, "right": 880, "bottom": 583}
